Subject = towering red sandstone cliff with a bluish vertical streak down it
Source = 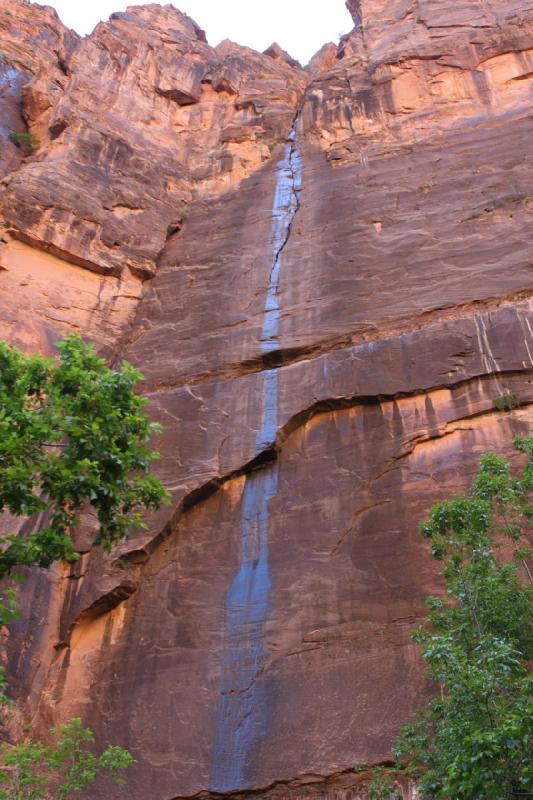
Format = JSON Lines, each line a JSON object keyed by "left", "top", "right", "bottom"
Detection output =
{"left": 0, "top": 0, "right": 533, "bottom": 800}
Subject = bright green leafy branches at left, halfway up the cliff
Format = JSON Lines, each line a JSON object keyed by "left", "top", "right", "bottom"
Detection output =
{"left": 0, "top": 335, "right": 166, "bottom": 577}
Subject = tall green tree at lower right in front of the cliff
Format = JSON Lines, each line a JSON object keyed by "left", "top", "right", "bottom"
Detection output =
{"left": 367, "top": 436, "right": 533, "bottom": 800}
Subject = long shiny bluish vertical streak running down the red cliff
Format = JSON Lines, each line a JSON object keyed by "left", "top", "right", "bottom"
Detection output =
{"left": 210, "top": 113, "right": 302, "bottom": 792}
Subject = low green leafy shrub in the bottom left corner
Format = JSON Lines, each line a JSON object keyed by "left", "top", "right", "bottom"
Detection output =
{"left": 0, "top": 717, "right": 134, "bottom": 800}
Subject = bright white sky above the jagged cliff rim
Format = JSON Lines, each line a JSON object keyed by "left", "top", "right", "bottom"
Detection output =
{"left": 45, "top": 0, "right": 353, "bottom": 64}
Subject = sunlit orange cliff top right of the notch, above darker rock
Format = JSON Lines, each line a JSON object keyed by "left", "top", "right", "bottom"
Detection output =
{"left": 304, "top": 0, "right": 533, "bottom": 161}
